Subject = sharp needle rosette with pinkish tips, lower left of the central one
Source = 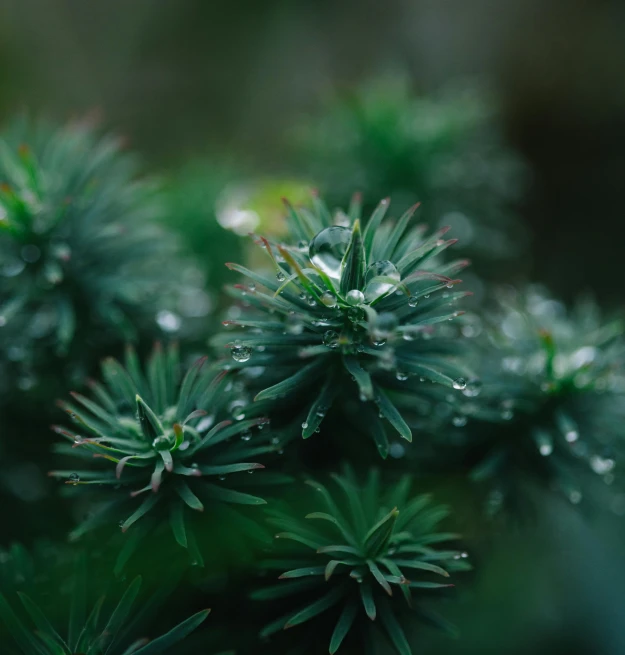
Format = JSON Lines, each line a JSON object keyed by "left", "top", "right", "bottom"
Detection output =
{"left": 51, "top": 345, "right": 275, "bottom": 563}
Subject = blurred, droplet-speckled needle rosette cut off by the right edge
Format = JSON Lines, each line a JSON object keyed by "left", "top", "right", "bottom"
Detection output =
{"left": 441, "top": 286, "right": 625, "bottom": 510}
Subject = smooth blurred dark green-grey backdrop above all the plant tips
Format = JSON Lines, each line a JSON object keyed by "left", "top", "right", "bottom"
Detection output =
{"left": 0, "top": 0, "right": 625, "bottom": 300}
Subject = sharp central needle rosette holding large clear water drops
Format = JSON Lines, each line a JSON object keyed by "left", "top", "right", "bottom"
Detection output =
{"left": 214, "top": 196, "right": 467, "bottom": 457}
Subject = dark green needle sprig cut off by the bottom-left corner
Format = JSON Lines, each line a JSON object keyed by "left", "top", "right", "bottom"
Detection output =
{"left": 0, "top": 546, "right": 210, "bottom": 655}
